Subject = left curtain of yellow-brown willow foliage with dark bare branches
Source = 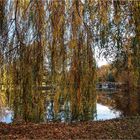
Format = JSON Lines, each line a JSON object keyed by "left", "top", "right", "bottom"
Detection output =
{"left": 1, "top": 0, "right": 45, "bottom": 121}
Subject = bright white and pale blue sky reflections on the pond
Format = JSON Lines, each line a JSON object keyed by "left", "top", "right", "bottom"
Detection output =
{"left": 0, "top": 103, "right": 120, "bottom": 123}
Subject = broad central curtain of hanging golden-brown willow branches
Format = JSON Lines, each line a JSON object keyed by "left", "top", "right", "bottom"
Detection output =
{"left": 48, "top": 1, "right": 96, "bottom": 119}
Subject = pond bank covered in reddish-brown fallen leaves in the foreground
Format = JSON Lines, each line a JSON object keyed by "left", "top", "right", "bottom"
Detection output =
{"left": 0, "top": 116, "right": 140, "bottom": 139}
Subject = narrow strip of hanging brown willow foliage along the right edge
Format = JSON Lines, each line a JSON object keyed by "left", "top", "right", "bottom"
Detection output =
{"left": 116, "top": 2, "right": 140, "bottom": 89}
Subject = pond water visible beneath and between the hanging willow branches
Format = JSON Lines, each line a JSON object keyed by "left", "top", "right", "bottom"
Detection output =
{"left": 0, "top": 91, "right": 140, "bottom": 123}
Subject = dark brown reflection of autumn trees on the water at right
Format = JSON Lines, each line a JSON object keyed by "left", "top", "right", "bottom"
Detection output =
{"left": 98, "top": 90, "right": 140, "bottom": 117}
